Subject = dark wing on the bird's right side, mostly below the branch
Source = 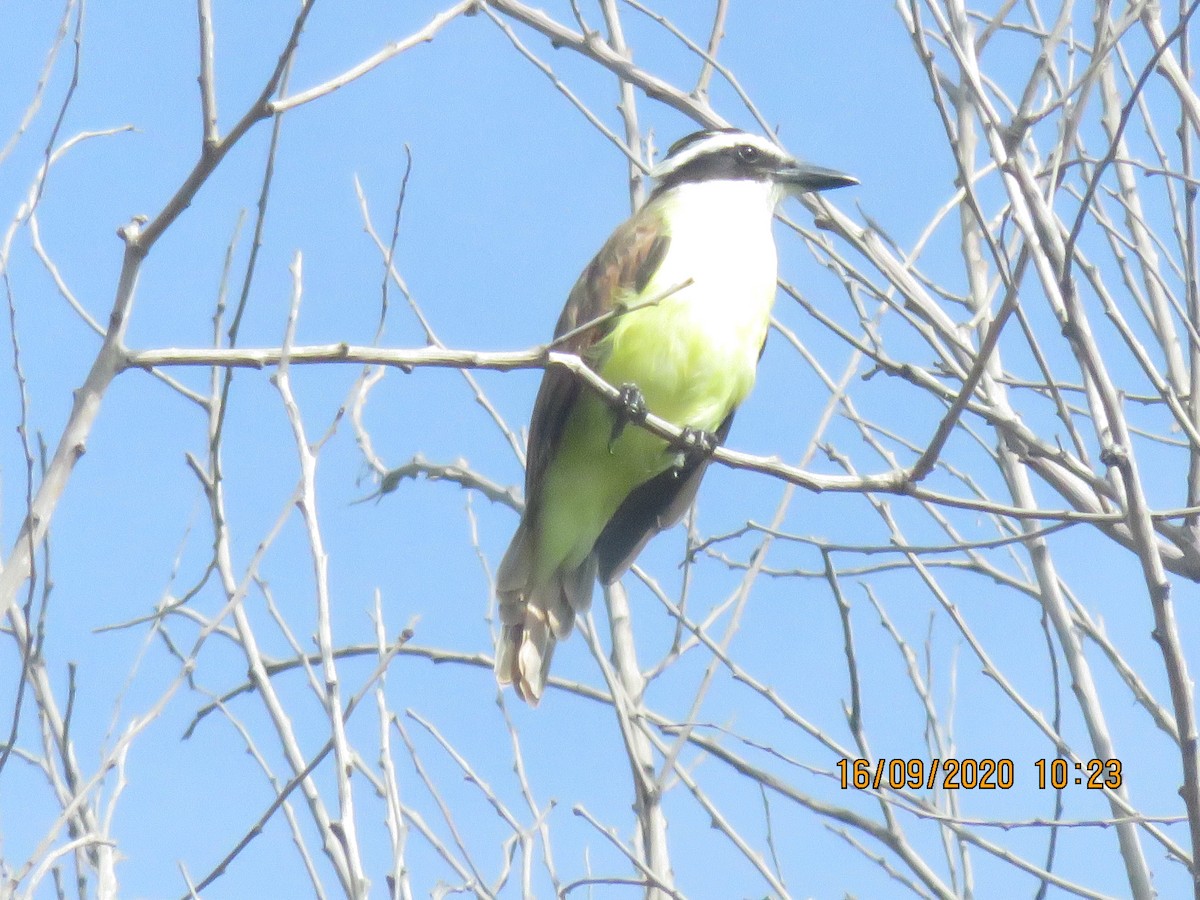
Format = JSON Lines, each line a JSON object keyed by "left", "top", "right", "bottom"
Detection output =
{"left": 595, "top": 413, "right": 733, "bottom": 584}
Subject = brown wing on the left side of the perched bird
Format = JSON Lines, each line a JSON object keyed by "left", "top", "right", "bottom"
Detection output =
{"left": 526, "top": 203, "right": 671, "bottom": 515}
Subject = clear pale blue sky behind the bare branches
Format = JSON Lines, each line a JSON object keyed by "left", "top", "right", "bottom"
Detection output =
{"left": 0, "top": 0, "right": 1198, "bottom": 898}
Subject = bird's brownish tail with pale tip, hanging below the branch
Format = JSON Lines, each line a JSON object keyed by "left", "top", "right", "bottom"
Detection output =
{"left": 496, "top": 520, "right": 596, "bottom": 706}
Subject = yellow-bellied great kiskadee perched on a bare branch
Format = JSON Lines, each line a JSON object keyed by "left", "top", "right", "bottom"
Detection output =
{"left": 496, "top": 128, "right": 858, "bottom": 704}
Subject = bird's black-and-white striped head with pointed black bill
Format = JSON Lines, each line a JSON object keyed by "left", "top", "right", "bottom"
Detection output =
{"left": 650, "top": 128, "right": 858, "bottom": 201}
